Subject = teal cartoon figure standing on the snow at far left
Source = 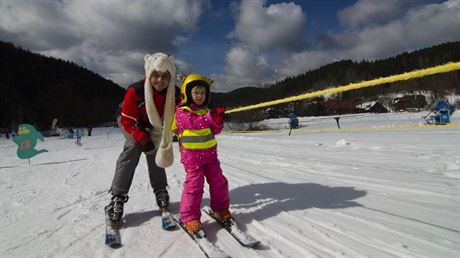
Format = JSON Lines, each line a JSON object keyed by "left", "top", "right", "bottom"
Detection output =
{"left": 13, "top": 124, "right": 48, "bottom": 159}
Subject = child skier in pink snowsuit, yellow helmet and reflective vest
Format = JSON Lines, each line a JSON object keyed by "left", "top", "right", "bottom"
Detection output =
{"left": 172, "top": 74, "right": 232, "bottom": 234}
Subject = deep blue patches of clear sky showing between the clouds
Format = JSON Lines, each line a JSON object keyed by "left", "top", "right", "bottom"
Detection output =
{"left": 179, "top": 0, "right": 356, "bottom": 74}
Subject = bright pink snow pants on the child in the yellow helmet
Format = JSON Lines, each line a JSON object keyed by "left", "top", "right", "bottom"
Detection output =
{"left": 179, "top": 159, "right": 230, "bottom": 223}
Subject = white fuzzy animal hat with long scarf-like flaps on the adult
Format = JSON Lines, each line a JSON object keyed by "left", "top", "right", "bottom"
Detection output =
{"left": 144, "top": 53, "right": 176, "bottom": 168}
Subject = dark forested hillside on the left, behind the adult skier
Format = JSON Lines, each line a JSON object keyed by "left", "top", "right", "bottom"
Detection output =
{"left": 0, "top": 41, "right": 125, "bottom": 130}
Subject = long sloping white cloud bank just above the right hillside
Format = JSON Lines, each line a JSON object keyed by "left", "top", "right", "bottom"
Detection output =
{"left": 278, "top": 0, "right": 460, "bottom": 81}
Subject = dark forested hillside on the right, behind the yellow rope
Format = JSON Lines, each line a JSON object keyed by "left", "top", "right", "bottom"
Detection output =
{"left": 212, "top": 42, "right": 460, "bottom": 118}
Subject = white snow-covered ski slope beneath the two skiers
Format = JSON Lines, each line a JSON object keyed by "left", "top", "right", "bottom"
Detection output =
{"left": 0, "top": 112, "right": 460, "bottom": 257}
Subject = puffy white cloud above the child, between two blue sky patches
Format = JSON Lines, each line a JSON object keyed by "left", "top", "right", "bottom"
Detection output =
{"left": 214, "top": 0, "right": 306, "bottom": 92}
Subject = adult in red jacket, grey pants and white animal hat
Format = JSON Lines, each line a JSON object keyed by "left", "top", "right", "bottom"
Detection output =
{"left": 105, "top": 53, "right": 180, "bottom": 223}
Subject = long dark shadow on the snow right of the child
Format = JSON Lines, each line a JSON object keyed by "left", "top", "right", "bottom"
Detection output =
{"left": 207, "top": 183, "right": 366, "bottom": 229}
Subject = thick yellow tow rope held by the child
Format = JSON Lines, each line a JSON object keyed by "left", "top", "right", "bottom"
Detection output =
{"left": 225, "top": 62, "right": 460, "bottom": 114}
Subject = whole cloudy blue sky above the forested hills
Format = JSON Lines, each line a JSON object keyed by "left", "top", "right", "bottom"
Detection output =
{"left": 0, "top": 0, "right": 460, "bottom": 92}
